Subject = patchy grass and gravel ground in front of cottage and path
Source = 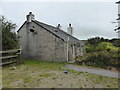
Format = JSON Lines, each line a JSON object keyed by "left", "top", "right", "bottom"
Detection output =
{"left": 2, "top": 60, "right": 118, "bottom": 88}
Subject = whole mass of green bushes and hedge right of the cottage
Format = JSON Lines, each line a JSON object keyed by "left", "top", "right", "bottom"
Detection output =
{"left": 76, "top": 38, "right": 120, "bottom": 70}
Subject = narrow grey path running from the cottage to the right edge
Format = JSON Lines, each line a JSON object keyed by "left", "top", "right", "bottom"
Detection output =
{"left": 62, "top": 65, "right": 120, "bottom": 78}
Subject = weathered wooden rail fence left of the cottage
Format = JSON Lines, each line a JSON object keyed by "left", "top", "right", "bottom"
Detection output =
{"left": 0, "top": 49, "right": 22, "bottom": 65}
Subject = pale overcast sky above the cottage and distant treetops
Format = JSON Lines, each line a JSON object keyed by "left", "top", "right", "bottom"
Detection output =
{"left": 0, "top": 2, "right": 118, "bottom": 39}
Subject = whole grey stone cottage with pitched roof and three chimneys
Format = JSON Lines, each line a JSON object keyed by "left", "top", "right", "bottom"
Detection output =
{"left": 17, "top": 12, "right": 84, "bottom": 62}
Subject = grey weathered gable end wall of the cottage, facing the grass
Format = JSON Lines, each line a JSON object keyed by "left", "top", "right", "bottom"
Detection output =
{"left": 19, "top": 23, "right": 66, "bottom": 62}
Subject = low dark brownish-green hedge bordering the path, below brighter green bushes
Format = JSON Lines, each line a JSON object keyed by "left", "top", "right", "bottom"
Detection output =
{"left": 81, "top": 51, "right": 120, "bottom": 68}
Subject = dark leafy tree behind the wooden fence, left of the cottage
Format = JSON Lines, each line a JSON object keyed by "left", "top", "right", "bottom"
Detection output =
{"left": 0, "top": 16, "right": 19, "bottom": 50}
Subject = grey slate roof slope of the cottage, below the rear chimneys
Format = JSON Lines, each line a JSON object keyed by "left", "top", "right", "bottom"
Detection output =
{"left": 33, "top": 20, "right": 83, "bottom": 43}
